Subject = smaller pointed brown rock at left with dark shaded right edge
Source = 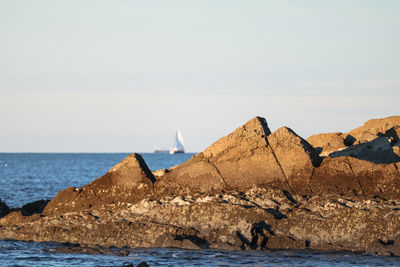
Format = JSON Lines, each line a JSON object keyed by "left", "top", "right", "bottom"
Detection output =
{"left": 44, "top": 153, "right": 156, "bottom": 213}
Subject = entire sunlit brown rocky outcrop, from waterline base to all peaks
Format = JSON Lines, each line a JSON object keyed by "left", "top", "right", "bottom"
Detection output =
{"left": 0, "top": 117, "right": 400, "bottom": 256}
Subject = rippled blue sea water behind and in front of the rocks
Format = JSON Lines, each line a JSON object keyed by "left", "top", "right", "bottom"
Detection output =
{"left": 0, "top": 153, "right": 400, "bottom": 267}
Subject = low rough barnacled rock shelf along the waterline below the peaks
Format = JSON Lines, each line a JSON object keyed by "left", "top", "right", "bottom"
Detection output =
{"left": 0, "top": 187, "right": 400, "bottom": 255}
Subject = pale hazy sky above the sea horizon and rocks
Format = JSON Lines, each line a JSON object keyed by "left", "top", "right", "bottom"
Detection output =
{"left": 0, "top": 0, "right": 400, "bottom": 152}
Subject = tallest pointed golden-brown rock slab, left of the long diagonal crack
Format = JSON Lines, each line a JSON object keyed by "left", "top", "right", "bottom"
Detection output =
{"left": 157, "top": 117, "right": 285, "bottom": 192}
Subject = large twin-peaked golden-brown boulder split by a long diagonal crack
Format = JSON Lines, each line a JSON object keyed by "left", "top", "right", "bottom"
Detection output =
{"left": 156, "top": 117, "right": 320, "bottom": 196}
